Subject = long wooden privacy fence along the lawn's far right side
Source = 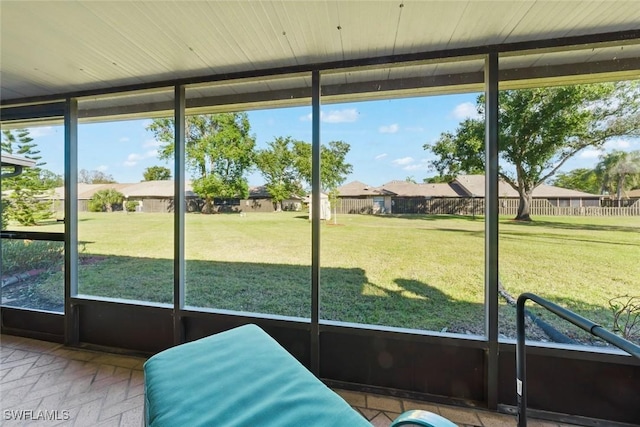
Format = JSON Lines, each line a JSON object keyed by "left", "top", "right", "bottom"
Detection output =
{"left": 336, "top": 197, "right": 640, "bottom": 217}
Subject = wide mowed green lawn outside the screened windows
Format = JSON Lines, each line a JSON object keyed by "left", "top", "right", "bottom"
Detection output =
{"left": 6, "top": 212, "right": 640, "bottom": 342}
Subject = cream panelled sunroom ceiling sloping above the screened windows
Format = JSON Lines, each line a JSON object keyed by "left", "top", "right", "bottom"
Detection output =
{"left": 0, "top": 0, "right": 640, "bottom": 115}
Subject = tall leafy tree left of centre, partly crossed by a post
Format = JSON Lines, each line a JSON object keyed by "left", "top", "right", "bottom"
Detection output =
{"left": 147, "top": 113, "right": 255, "bottom": 213}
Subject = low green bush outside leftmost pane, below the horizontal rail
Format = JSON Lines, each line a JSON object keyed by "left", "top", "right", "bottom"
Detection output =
{"left": 2, "top": 239, "right": 64, "bottom": 276}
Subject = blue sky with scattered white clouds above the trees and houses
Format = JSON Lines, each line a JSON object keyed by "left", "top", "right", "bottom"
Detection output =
{"left": 20, "top": 94, "right": 640, "bottom": 190}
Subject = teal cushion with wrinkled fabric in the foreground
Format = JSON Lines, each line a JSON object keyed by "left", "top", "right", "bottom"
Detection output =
{"left": 144, "top": 325, "right": 371, "bottom": 427}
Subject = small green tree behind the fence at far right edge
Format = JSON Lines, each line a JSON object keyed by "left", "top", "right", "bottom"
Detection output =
{"left": 594, "top": 150, "right": 640, "bottom": 206}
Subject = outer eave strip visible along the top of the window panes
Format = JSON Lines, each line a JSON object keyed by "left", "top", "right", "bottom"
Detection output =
{"left": 57, "top": 58, "right": 640, "bottom": 122}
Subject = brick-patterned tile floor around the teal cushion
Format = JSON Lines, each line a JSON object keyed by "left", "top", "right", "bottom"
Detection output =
{"left": 0, "top": 335, "right": 592, "bottom": 427}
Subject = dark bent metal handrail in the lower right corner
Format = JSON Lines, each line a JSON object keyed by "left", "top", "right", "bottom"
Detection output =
{"left": 516, "top": 293, "right": 640, "bottom": 427}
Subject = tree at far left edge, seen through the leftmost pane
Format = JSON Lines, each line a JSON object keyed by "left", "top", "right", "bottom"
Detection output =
{"left": 2, "top": 129, "right": 57, "bottom": 225}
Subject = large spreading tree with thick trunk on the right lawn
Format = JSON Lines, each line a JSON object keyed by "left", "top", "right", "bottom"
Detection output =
{"left": 424, "top": 81, "right": 640, "bottom": 221}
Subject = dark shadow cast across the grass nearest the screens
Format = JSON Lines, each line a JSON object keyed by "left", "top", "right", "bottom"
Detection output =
{"left": 3, "top": 255, "right": 632, "bottom": 346}
